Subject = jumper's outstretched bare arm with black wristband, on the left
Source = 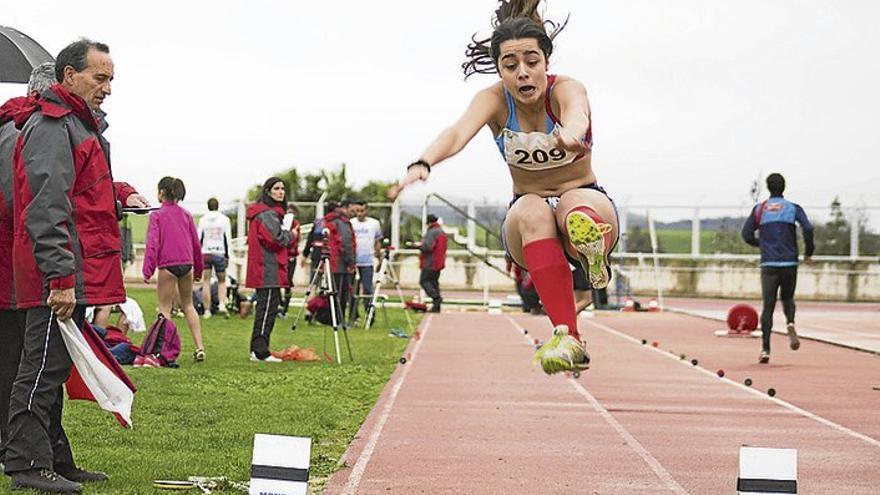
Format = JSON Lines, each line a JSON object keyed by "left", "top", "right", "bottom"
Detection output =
{"left": 388, "top": 86, "right": 500, "bottom": 198}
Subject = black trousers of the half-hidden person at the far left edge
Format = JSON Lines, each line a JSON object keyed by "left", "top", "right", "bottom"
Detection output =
{"left": 0, "top": 310, "right": 26, "bottom": 462}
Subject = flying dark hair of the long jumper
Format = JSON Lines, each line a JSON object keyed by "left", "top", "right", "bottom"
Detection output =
{"left": 461, "top": 0, "right": 568, "bottom": 79}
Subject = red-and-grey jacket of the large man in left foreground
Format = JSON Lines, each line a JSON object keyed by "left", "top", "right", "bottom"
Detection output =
{"left": 13, "top": 84, "right": 135, "bottom": 309}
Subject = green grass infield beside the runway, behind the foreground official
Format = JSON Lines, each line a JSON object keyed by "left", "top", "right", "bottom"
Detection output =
{"left": 54, "top": 289, "right": 416, "bottom": 494}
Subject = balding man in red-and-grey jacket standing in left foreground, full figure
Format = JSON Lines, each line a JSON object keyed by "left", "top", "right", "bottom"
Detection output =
{"left": 5, "top": 39, "right": 148, "bottom": 493}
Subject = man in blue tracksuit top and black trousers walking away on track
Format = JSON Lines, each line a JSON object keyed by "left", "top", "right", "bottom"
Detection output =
{"left": 742, "top": 174, "right": 814, "bottom": 364}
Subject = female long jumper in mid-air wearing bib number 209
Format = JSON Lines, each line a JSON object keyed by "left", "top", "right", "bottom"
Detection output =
{"left": 389, "top": 0, "right": 618, "bottom": 374}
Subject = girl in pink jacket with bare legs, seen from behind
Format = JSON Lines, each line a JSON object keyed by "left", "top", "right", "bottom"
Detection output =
{"left": 143, "top": 177, "right": 205, "bottom": 362}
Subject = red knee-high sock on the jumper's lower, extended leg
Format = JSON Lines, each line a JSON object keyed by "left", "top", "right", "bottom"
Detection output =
{"left": 523, "top": 239, "right": 580, "bottom": 338}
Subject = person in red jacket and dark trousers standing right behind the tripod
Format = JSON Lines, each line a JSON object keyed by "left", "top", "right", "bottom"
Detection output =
{"left": 324, "top": 203, "right": 357, "bottom": 321}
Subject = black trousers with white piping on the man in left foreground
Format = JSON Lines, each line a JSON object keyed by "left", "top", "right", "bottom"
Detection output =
{"left": 6, "top": 306, "right": 85, "bottom": 473}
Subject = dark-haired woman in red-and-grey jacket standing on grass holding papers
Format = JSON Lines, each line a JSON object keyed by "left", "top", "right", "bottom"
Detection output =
{"left": 245, "top": 177, "right": 293, "bottom": 363}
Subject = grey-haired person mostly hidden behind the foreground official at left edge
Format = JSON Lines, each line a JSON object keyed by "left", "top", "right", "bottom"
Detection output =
{"left": 0, "top": 62, "right": 55, "bottom": 480}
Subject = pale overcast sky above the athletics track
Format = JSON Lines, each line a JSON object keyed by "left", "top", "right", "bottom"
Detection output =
{"left": 0, "top": 0, "right": 880, "bottom": 215}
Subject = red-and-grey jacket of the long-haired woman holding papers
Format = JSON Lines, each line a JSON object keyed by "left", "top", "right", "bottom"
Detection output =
{"left": 245, "top": 202, "right": 293, "bottom": 289}
